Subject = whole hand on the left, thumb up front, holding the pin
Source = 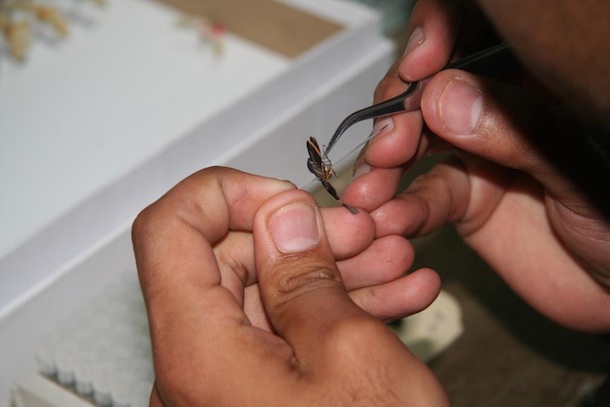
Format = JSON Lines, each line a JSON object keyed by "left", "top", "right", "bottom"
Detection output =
{"left": 133, "top": 168, "right": 447, "bottom": 406}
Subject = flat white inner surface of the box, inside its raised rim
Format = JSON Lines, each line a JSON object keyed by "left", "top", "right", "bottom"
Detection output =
{"left": 0, "top": 0, "right": 291, "bottom": 262}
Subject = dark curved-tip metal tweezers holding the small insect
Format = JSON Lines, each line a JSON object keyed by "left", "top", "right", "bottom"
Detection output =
{"left": 324, "top": 43, "right": 518, "bottom": 158}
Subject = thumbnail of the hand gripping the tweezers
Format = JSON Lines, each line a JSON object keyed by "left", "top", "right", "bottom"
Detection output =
{"left": 439, "top": 79, "right": 483, "bottom": 134}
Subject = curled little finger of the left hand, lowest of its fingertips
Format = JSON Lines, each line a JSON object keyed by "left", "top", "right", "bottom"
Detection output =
{"left": 350, "top": 269, "right": 441, "bottom": 321}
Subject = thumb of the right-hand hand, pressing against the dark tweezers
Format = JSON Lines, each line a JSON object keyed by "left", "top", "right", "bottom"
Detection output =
{"left": 421, "top": 70, "right": 551, "bottom": 173}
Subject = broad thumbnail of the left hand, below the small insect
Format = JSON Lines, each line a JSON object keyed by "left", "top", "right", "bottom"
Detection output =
{"left": 269, "top": 202, "right": 320, "bottom": 254}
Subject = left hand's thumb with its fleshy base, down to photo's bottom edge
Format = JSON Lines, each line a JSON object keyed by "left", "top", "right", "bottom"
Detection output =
{"left": 254, "top": 190, "right": 447, "bottom": 406}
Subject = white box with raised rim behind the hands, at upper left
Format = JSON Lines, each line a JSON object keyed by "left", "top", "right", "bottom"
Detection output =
{"left": 0, "top": 0, "right": 393, "bottom": 403}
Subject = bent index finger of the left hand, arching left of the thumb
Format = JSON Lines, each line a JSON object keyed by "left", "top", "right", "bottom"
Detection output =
{"left": 132, "top": 168, "right": 294, "bottom": 318}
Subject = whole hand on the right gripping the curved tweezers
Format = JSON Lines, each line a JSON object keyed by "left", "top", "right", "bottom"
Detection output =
{"left": 343, "top": 0, "right": 610, "bottom": 332}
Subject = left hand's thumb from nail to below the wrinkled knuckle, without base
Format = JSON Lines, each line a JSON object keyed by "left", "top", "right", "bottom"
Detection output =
{"left": 254, "top": 191, "right": 378, "bottom": 369}
